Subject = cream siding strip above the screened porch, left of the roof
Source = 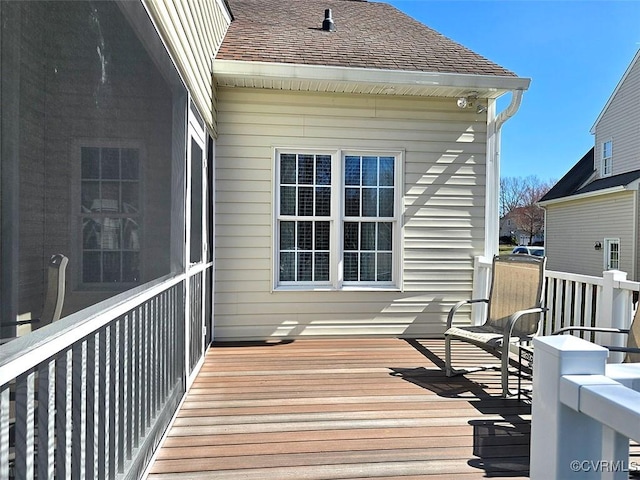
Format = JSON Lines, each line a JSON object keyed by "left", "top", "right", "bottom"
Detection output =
{"left": 144, "top": 0, "right": 231, "bottom": 133}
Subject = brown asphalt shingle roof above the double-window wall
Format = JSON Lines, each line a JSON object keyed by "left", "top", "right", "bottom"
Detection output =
{"left": 216, "top": 0, "right": 516, "bottom": 77}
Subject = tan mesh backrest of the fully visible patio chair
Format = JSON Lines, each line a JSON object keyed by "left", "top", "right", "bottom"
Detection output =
{"left": 486, "top": 255, "right": 546, "bottom": 337}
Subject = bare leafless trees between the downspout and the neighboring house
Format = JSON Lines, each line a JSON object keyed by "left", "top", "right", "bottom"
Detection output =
{"left": 500, "top": 176, "right": 555, "bottom": 243}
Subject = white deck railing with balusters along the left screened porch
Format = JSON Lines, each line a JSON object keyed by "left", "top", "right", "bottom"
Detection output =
{"left": 0, "top": 272, "right": 210, "bottom": 480}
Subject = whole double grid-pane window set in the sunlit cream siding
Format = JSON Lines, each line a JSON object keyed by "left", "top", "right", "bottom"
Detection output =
{"left": 275, "top": 152, "right": 399, "bottom": 288}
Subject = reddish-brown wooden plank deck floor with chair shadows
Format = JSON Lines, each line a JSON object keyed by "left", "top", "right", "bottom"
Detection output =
{"left": 148, "top": 339, "right": 530, "bottom": 480}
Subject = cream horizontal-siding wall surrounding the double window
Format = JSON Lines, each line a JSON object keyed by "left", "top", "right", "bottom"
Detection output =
{"left": 215, "top": 88, "right": 486, "bottom": 340}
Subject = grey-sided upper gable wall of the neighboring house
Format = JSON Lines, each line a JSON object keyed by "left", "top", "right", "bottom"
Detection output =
{"left": 594, "top": 54, "right": 640, "bottom": 176}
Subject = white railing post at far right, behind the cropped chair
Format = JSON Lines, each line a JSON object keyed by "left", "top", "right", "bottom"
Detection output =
{"left": 596, "top": 270, "right": 631, "bottom": 363}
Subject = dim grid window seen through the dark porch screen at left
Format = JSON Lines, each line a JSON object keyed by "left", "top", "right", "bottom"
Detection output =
{"left": 80, "top": 146, "right": 142, "bottom": 285}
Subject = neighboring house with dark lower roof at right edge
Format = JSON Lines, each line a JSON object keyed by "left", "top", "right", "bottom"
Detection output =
{"left": 539, "top": 51, "right": 640, "bottom": 280}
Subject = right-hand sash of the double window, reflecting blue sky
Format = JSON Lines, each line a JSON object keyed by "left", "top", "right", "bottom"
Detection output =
{"left": 343, "top": 155, "right": 395, "bottom": 283}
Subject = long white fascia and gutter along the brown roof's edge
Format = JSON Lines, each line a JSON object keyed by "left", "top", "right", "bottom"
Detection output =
{"left": 213, "top": 59, "right": 531, "bottom": 98}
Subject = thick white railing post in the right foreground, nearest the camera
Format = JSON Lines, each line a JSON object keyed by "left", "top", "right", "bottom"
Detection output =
{"left": 530, "top": 335, "right": 608, "bottom": 480}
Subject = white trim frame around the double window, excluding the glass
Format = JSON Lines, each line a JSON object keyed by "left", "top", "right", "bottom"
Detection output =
{"left": 271, "top": 147, "right": 404, "bottom": 291}
